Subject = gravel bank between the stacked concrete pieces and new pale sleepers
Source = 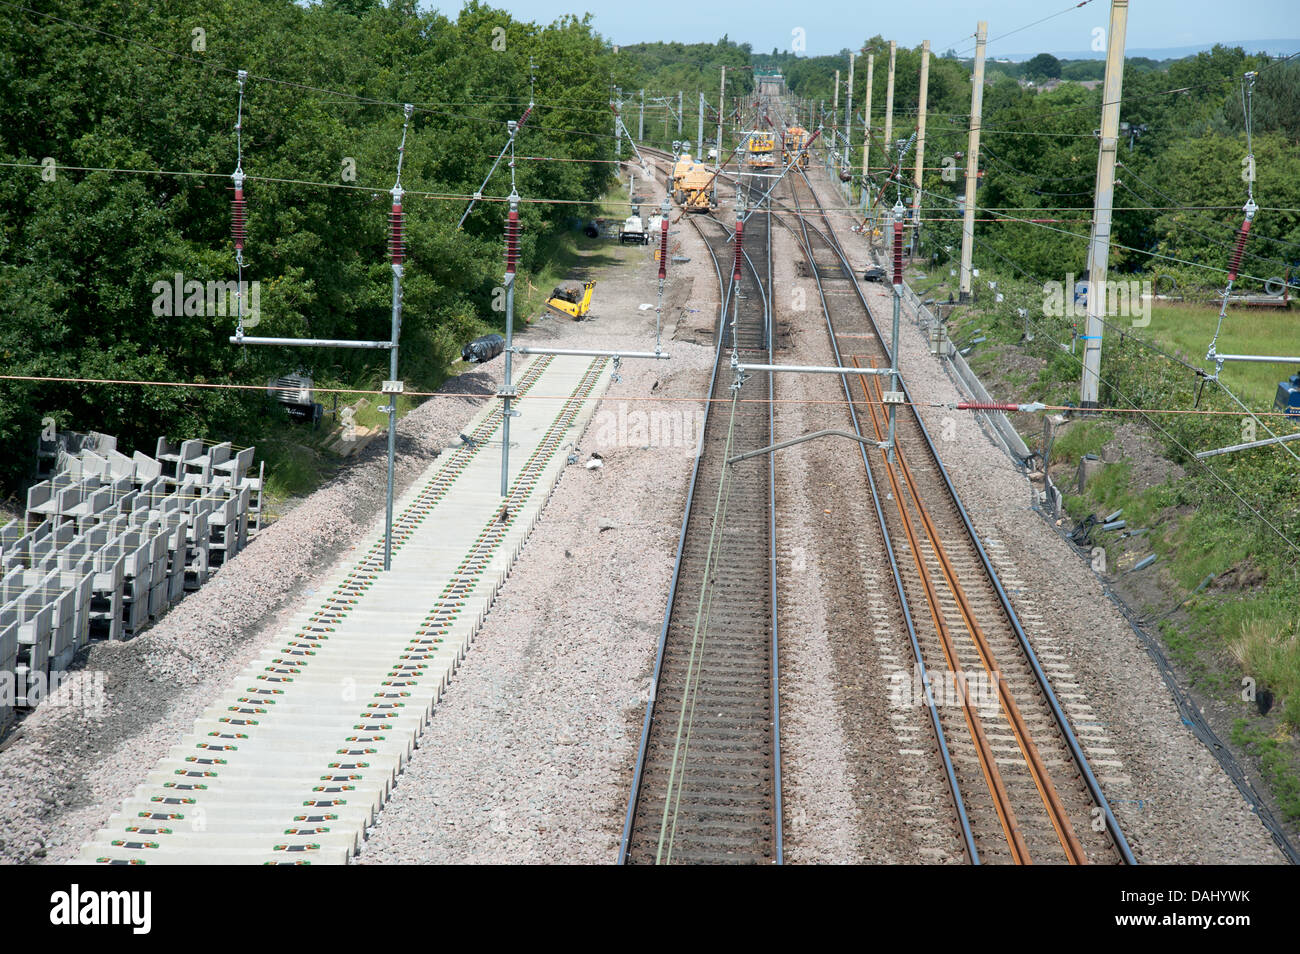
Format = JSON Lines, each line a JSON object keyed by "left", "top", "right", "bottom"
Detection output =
{"left": 0, "top": 363, "right": 501, "bottom": 863}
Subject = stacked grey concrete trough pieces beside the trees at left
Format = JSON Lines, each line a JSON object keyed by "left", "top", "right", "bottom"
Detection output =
{"left": 0, "top": 432, "right": 263, "bottom": 733}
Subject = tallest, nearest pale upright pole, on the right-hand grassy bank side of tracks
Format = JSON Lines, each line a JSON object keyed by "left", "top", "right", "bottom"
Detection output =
{"left": 1079, "top": 0, "right": 1128, "bottom": 407}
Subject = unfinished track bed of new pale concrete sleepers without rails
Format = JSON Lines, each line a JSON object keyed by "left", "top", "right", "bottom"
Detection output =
{"left": 81, "top": 356, "right": 608, "bottom": 864}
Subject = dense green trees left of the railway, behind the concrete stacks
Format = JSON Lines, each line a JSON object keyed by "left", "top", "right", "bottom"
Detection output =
{"left": 0, "top": 0, "right": 624, "bottom": 489}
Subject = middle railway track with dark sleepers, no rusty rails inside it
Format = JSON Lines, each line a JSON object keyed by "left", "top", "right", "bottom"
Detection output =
{"left": 619, "top": 158, "right": 781, "bottom": 864}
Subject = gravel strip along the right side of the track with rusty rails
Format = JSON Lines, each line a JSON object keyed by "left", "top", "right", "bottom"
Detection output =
{"left": 813, "top": 172, "right": 1283, "bottom": 864}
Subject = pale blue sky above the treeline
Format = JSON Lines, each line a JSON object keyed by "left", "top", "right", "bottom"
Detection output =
{"left": 421, "top": 0, "right": 1300, "bottom": 56}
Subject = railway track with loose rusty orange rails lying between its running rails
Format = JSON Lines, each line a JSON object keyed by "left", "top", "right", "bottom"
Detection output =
{"left": 785, "top": 166, "right": 1132, "bottom": 863}
